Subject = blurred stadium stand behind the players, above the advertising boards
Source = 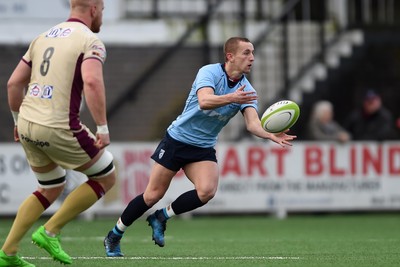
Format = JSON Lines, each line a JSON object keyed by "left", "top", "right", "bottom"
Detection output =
{"left": 0, "top": 0, "right": 400, "bottom": 142}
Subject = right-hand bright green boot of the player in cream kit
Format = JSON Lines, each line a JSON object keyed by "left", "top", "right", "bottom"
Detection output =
{"left": 32, "top": 226, "right": 72, "bottom": 264}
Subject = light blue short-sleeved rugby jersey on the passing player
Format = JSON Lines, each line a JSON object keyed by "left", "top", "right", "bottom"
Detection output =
{"left": 167, "top": 63, "right": 258, "bottom": 147}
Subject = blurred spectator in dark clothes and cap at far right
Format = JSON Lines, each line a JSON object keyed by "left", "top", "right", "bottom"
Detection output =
{"left": 344, "top": 89, "right": 395, "bottom": 141}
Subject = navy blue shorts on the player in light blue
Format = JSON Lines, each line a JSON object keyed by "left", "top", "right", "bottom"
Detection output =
{"left": 151, "top": 133, "right": 217, "bottom": 171}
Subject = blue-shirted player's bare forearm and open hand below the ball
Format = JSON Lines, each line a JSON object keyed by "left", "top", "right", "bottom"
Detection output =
{"left": 243, "top": 107, "right": 297, "bottom": 147}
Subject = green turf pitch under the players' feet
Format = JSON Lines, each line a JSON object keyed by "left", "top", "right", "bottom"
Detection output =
{"left": 0, "top": 213, "right": 400, "bottom": 267}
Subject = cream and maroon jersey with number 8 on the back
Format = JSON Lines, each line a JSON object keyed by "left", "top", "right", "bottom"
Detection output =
{"left": 20, "top": 19, "right": 106, "bottom": 130}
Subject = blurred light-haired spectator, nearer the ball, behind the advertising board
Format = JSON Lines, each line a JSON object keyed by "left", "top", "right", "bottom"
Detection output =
{"left": 307, "top": 101, "right": 350, "bottom": 142}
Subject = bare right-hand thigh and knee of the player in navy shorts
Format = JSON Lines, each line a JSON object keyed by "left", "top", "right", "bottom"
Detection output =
{"left": 183, "top": 160, "right": 219, "bottom": 193}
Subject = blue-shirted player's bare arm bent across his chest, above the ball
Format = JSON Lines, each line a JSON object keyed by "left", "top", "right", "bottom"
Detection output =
{"left": 197, "top": 85, "right": 257, "bottom": 110}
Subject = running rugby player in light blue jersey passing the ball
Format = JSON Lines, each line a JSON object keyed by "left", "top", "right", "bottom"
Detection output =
{"left": 104, "top": 37, "right": 296, "bottom": 257}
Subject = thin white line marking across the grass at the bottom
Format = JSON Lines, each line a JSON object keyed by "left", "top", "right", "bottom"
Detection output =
{"left": 22, "top": 256, "right": 300, "bottom": 261}
